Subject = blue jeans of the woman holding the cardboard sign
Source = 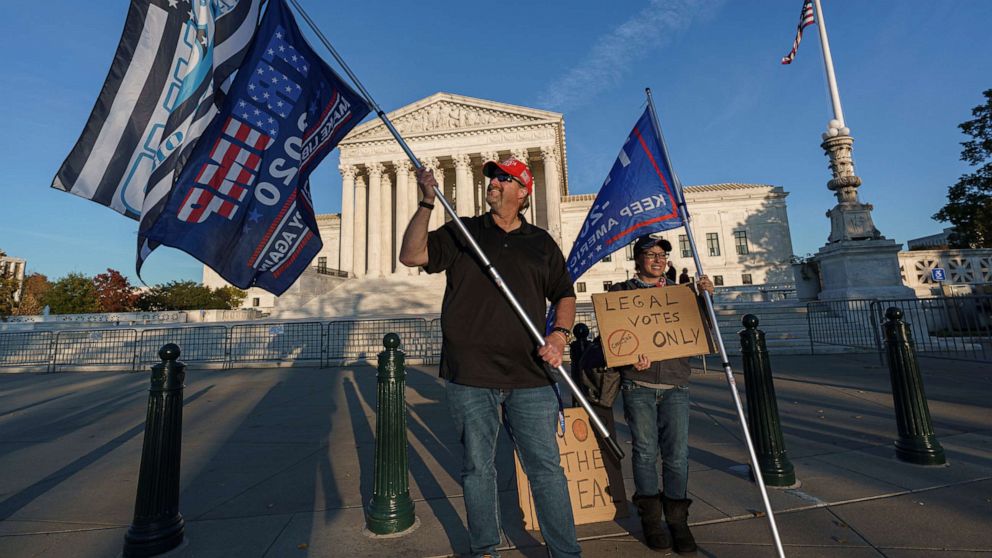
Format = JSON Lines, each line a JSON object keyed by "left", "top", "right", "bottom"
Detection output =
{"left": 621, "top": 380, "right": 689, "bottom": 500}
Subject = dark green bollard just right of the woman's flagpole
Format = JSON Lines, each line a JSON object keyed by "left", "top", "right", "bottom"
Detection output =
{"left": 740, "top": 314, "right": 796, "bottom": 487}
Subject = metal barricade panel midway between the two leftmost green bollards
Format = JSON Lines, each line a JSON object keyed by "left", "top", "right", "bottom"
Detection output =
{"left": 228, "top": 322, "right": 324, "bottom": 364}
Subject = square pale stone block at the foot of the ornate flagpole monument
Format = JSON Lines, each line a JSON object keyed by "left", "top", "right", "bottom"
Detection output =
{"left": 816, "top": 238, "right": 916, "bottom": 300}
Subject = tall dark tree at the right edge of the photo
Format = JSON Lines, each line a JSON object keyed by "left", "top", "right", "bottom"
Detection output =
{"left": 933, "top": 89, "right": 992, "bottom": 248}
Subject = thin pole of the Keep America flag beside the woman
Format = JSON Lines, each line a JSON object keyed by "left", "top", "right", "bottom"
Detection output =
{"left": 645, "top": 88, "right": 785, "bottom": 558}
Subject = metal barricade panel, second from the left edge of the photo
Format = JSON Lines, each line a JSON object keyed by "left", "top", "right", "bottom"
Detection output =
{"left": 50, "top": 329, "right": 138, "bottom": 372}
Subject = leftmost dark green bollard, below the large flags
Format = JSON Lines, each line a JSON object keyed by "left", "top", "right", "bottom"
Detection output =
{"left": 123, "top": 343, "right": 186, "bottom": 558}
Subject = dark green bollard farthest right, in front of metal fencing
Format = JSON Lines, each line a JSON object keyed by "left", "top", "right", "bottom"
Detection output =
{"left": 882, "top": 306, "right": 947, "bottom": 465}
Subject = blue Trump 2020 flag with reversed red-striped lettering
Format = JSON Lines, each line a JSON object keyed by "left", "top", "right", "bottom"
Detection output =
{"left": 139, "top": 0, "right": 369, "bottom": 295}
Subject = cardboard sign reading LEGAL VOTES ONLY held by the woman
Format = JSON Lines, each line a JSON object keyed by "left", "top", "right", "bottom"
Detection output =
{"left": 592, "top": 285, "right": 715, "bottom": 366}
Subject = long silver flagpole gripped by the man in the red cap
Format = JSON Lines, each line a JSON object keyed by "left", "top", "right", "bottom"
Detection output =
{"left": 290, "top": 0, "right": 624, "bottom": 462}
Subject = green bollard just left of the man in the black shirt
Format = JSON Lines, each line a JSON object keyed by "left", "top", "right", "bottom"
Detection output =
{"left": 365, "top": 333, "right": 417, "bottom": 536}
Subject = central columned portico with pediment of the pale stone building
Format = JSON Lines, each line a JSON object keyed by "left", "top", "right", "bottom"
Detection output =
{"left": 340, "top": 93, "right": 568, "bottom": 278}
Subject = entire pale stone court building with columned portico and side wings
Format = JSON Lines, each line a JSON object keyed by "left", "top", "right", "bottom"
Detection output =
{"left": 204, "top": 93, "right": 792, "bottom": 309}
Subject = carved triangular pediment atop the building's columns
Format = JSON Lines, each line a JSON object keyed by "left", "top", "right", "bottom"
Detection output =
{"left": 341, "top": 93, "right": 562, "bottom": 145}
